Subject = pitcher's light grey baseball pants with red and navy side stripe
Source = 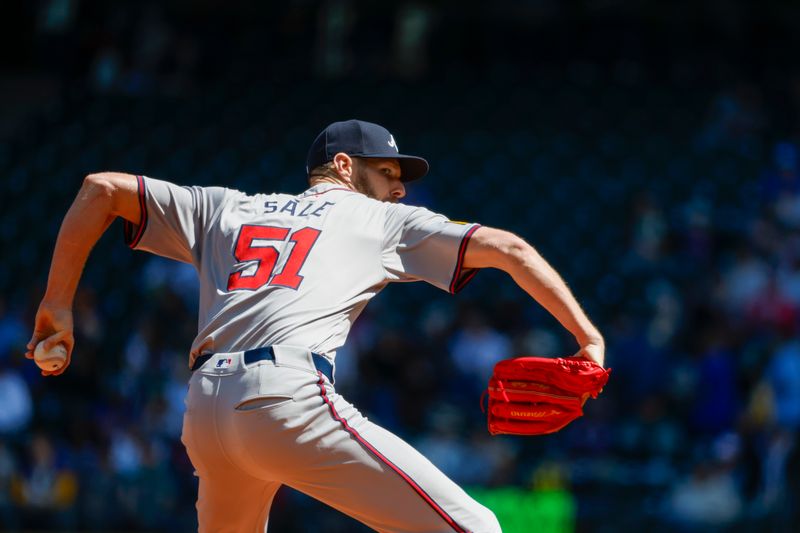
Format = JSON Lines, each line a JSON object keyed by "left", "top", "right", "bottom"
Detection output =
{"left": 182, "top": 346, "right": 500, "bottom": 533}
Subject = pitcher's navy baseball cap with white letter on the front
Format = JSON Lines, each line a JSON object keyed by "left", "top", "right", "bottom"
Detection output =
{"left": 306, "top": 120, "right": 429, "bottom": 181}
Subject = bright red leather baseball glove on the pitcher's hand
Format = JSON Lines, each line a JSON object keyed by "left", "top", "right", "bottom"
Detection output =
{"left": 481, "top": 357, "right": 611, "bottom": 435}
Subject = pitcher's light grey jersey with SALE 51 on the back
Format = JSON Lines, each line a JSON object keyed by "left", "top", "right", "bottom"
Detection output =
{"left": 125, "top": 177, "right": 478, "bottom": 366}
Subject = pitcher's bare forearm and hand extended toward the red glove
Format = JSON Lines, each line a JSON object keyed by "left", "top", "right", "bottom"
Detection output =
{"left": 464, "top": 226, "right": 605, "bottom": 366}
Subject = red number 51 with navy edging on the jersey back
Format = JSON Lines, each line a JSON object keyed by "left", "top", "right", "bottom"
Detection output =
{"left": 228, "top": 224, "right": 321, "bottom": 291}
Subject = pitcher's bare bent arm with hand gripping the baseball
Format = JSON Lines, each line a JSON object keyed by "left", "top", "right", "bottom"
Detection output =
{"left": 25, "top": 172, "right": 141, "bottom": 375}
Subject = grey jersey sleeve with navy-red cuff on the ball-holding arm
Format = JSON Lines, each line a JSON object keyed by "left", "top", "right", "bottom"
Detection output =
{"left": 123, "top": 176, "right": 229, "bottom": 264}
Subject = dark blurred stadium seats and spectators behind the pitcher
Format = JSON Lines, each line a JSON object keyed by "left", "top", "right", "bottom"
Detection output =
{"left": 0, "top": 0, "right": 800, "bottom": 532}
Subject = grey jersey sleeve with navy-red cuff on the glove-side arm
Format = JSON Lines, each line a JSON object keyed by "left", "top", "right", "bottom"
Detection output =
{"left": 382, "top": 204, "right": 480, "bottom": 294}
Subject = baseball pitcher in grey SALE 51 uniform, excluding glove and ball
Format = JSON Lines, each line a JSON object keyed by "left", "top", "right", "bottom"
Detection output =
{"left": 26, "top": 120, "right": 604, "bottom": 532}
